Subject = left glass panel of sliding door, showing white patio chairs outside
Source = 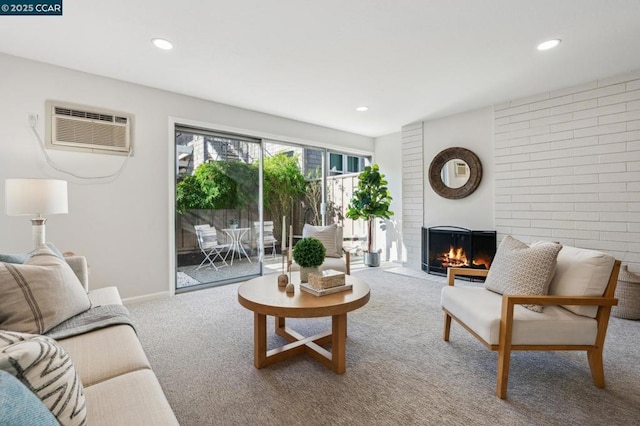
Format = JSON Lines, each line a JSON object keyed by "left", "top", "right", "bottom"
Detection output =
{"left": 175, "top": 126, "right": 263, "bottom": 292}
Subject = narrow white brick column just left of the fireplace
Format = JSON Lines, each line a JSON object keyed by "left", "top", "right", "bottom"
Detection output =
{"left": 402, "top": 122, "right": 424, "bottom": 269}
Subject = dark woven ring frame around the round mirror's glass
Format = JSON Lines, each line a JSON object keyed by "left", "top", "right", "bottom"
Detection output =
{"left": 429, "top": 147, "right": 482, "bottom": 200}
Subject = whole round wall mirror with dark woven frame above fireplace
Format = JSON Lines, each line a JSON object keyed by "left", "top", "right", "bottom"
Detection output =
{"left": 429, "top": 147, "right": 482, "bottom": 200}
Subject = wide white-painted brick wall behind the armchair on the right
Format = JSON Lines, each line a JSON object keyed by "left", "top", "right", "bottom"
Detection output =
{"left": 496, "top": 71, "right": 640, "bottom": 265}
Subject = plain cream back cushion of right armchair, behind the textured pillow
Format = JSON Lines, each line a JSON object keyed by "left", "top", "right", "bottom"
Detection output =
{"left": 549, "top": 247, "right": 615, "bottom": 318}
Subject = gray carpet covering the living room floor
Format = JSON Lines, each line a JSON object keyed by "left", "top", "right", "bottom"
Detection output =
{"left": 129, "top": 268, "right": 640, "bottom": 425}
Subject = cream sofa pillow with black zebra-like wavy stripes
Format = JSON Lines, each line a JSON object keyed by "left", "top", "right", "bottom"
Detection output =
{"left": 0, "top": 331, "right": 87, "bottom": 426}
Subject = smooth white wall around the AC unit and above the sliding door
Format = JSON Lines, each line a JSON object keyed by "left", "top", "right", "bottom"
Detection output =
{"left": 0, "top": 54, "right": 373, "bottom": 298}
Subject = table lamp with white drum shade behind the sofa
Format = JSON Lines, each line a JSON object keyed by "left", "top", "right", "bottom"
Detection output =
{"left": 5, "top": 179, "right": 69, "bottom": 247}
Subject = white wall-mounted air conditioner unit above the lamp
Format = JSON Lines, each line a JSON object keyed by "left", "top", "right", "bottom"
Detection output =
{"left": 45, "top": 101, "right": 133, "bottom": 155}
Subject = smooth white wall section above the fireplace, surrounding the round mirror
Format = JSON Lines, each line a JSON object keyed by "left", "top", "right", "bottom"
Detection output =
{"left": 423, "top": 107, "right": 495, "bottom": 230}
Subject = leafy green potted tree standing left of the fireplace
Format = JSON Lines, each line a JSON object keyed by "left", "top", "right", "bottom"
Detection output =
{"left": 346, "top": 164, "right": 393, "bottom": 266}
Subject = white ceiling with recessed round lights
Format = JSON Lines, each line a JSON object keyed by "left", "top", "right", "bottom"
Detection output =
{"left": 0, "top": 0, "right": 640, "bottom": 137}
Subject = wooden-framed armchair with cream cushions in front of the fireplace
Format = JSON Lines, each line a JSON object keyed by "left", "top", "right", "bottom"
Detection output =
{"left": 441, "top": 246, "right": 620, "bottom": 399}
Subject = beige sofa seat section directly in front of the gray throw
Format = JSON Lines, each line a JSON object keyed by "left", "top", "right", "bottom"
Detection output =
{"left": 58, "top": 324, "right": 151, "bottom": 386}
